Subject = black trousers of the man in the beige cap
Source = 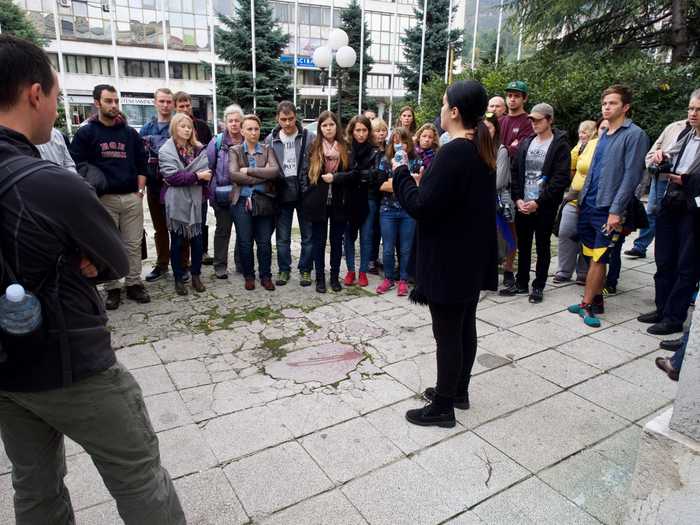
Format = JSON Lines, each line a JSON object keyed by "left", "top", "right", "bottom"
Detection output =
{"left": 515, "top": 208, "right": 556, "bottom": 288}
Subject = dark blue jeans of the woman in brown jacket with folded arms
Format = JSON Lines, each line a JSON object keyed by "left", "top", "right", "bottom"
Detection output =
{"left": 232, "top": 197, "right": 275, "bottom": 279}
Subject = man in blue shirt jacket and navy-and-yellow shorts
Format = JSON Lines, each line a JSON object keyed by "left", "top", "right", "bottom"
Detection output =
{"left": 569, "top": 85, "right": 649, "bottom": 327}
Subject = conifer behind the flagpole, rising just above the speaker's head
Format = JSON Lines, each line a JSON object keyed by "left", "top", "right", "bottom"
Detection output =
{"left": 399, "top": 0, "right": 462, "bottom": 98}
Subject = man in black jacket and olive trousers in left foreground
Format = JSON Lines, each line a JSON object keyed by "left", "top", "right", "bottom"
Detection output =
{"left": 0, "top": 34, "right": 185, "bottom": 525}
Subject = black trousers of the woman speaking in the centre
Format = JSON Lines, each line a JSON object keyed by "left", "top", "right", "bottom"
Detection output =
{"left": 430, "top": 294, "right": 479, "bottom": 397}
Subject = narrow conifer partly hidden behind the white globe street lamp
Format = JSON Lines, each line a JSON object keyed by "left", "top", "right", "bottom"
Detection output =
{"left": 336, "top": 0, "right": 374, "bottom": 122}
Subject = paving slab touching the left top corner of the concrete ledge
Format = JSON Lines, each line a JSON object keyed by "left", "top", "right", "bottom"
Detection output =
{"left": 571, "top": 374, "right": 671, "bottom": 421}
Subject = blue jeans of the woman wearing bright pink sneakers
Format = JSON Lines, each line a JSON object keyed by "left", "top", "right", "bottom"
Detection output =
{"left": 379, "top": 206, "right": 416, "bottom": 281}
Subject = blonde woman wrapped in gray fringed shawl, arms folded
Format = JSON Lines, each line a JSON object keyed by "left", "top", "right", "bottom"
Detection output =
{"left": 158, "top": 113, "right": 211, "bottom": 295}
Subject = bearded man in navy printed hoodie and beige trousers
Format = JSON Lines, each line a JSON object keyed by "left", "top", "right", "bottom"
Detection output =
{"left": 70, "top": 84, "right": 151, "bottom": 310}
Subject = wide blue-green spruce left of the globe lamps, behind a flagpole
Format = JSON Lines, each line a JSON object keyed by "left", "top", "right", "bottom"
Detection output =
{"left": 215, "top": 0, "right": 293, "bottom": 130}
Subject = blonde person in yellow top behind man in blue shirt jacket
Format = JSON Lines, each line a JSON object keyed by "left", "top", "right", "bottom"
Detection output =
{"left": 553, "top": 120, "right": 598, "bottom": 284}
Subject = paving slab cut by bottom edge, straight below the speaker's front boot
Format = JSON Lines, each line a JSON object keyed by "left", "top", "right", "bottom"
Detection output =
{"left": 341, "top": 459, "right": 467, "bottom": 525}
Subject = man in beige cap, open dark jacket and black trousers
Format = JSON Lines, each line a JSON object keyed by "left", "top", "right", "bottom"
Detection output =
{"left": 501, "top": 103, "right": 571, "bottom": 303}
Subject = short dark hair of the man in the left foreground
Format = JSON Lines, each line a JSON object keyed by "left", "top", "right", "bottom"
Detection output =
{"left": 0, "top": 34, "right": 54, "bottom": 110}
